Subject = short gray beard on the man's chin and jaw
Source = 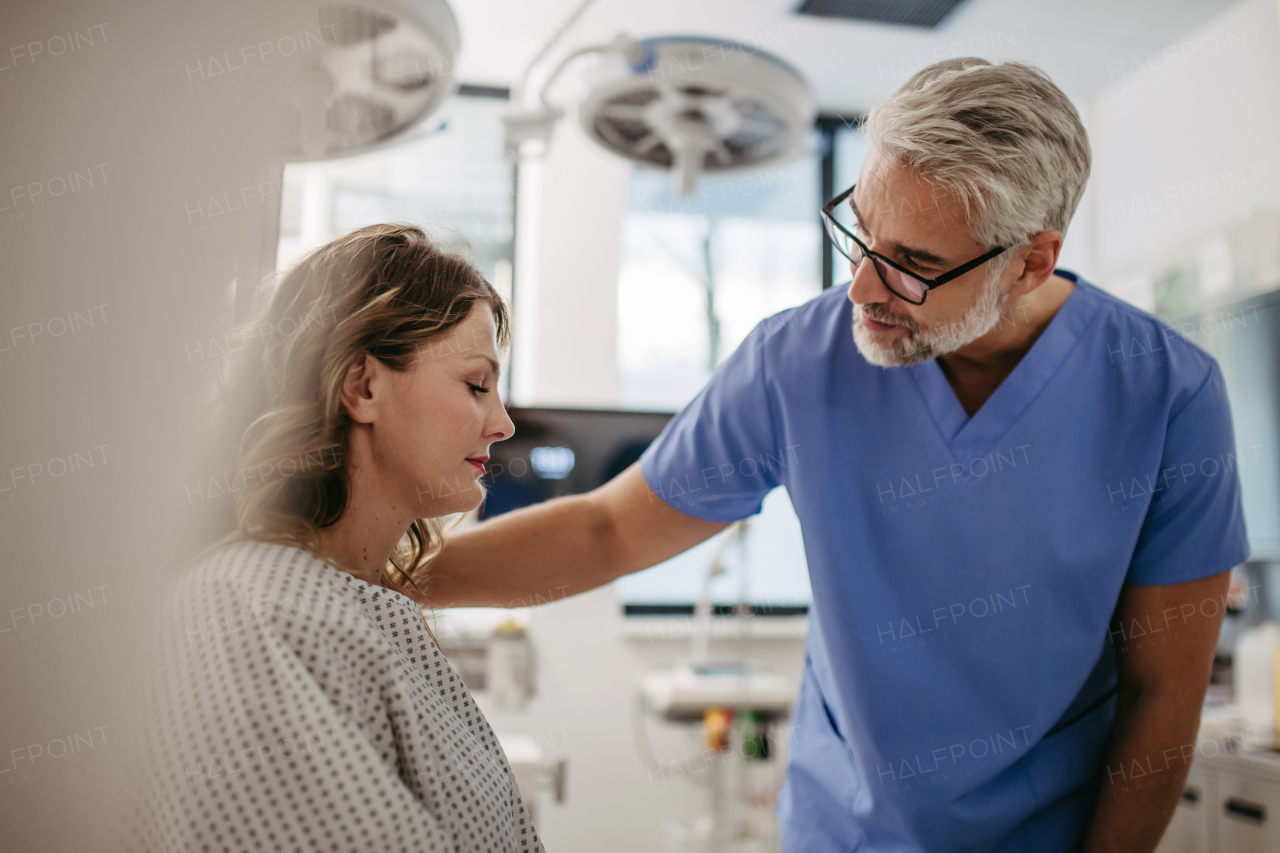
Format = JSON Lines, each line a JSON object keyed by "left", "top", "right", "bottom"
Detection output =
{"left": 854, "top": 273, "right": 1009, "bottom": 368}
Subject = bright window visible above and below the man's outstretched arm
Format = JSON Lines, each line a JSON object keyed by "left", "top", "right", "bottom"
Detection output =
{"left": 613, "top": 117, "right": 867, "bottom": 613}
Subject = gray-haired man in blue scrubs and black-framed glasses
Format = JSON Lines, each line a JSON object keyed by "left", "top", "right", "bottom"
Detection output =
{"left": 420, "top": 59, "right": 1248, "bottom": 853}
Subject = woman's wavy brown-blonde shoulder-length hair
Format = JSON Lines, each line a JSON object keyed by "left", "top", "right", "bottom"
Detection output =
{"left": 202, "top": 224, "right": 509, "bottom": 603}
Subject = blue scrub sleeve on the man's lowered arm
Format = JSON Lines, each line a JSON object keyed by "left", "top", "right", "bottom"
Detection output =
{"left": 1125, "top": 364, "right": 1249, "bottom": 585}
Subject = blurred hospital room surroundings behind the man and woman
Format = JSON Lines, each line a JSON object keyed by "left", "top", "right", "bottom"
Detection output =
{"left": 0, "top": 0, "right": 1280, "bottom": 853}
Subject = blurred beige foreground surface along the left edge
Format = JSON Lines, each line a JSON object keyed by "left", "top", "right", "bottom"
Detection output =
{"left": 0, "top": 0, "right": 335, "bottom": 852}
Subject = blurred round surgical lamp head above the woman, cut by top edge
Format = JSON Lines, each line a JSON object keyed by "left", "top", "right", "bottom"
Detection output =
{"left": 285, "top": 0, "right": 460, "bottom": 161}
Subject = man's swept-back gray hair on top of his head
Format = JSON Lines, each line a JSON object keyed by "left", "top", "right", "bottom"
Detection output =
{"left": 863, "top": 56, "right": 1089, "bottom": 247}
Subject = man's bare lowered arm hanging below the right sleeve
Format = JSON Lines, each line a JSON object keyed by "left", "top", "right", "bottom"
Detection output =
{"left": 1082, "top": 571, "right": 1231, "bottom": 853}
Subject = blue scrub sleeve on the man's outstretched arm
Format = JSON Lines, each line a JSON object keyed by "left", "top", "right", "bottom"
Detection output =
{"left": 640, "top": 319, "right": 778, "bottom": 521}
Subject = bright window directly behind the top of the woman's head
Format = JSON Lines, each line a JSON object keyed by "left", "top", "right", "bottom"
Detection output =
{"left": 276, "top": 88, "right": 515, "bottom": 307}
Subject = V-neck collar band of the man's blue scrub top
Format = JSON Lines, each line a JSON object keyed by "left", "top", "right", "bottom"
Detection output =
{"left": 909, "top": 269, "right": 1098, "bottom": 456}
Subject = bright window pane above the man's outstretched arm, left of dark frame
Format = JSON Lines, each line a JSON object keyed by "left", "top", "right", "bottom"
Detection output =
{"left": 618, "top": 128, "right": 822, "bottom": 411}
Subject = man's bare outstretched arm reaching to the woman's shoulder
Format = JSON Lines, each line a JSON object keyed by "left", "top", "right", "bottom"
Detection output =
{"left": 413, "top": 462, "right": 728, "bottom": 607}
